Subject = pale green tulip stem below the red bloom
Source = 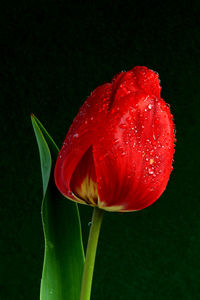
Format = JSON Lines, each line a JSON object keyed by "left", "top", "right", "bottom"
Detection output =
{"left": 80, "top": 207, "right": 103, "bottom": 300}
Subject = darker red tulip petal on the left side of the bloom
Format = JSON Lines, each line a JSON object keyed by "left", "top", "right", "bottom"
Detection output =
{"left": 54, "top": 84, "right": 111, "bottom": 205}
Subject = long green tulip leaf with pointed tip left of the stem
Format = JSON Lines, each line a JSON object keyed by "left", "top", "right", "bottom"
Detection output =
{"left": 31, "top": 115, "right": 84, "bottom": 300}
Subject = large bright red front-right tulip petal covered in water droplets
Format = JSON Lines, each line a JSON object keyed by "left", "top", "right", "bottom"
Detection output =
{"left": 94, "top": 68, "right": 174, "bottom": 211}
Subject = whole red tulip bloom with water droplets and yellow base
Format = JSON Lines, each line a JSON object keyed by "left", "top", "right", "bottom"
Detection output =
{"left": 55, "top": 66, "right": 175, "bottom": 212}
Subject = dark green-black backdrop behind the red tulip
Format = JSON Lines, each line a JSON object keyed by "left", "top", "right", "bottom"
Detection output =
{"left": 0, "top": 0, "right": 200, "bottom": 300}
